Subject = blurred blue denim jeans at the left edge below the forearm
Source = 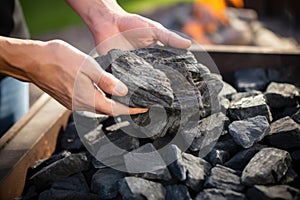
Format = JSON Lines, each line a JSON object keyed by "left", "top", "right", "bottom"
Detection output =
{"left": 0, "top": 77, "right": 29, "bottom": 137}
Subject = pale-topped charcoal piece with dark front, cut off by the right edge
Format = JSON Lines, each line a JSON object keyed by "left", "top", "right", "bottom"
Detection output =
{"left": 265, "top": 82, "right": 300, "bottom": 108}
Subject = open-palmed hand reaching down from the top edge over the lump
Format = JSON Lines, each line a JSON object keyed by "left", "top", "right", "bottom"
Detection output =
{"left": 66, "top": 0, "right": 191, "bottom": 53}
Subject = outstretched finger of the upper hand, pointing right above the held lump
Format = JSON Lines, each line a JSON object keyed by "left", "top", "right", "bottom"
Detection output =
{"left": 154, "top": 27, "right": 192, "bottom": 49}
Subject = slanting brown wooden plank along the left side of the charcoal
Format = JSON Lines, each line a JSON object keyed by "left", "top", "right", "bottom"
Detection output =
{"left": 0, "top": 94, "right": 70, "bottom": 200}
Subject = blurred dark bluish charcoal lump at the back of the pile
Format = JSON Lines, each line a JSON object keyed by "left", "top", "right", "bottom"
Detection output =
{"left": 234, "top": 68, "right": 279, "bottom": 92}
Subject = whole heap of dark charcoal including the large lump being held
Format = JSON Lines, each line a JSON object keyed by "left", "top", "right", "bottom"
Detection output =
{"left": 20, "top": 47, "right": 300, "bottom": 200}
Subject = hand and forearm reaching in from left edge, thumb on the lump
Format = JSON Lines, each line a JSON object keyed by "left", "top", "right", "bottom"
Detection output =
{"left": 0, "top": 37, "right": 148, "bottom": 115}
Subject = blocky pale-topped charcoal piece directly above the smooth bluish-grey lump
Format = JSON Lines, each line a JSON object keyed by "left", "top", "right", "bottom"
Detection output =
{"left": 228, "top": 94, "right": 272, "bottom": 121}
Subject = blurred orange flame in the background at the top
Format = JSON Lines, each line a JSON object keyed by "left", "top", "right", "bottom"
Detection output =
{"left": 183, "top": 0, "right": 244, "bottom": 44}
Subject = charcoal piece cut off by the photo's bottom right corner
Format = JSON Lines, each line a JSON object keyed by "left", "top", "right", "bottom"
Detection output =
{"left": 246, "top": 185, "right": 300, "bottom": 200}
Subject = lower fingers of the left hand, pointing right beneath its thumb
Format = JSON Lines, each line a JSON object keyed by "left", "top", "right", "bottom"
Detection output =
{"left": 95, "top": 87, "right": 148, "bottom": 116}
